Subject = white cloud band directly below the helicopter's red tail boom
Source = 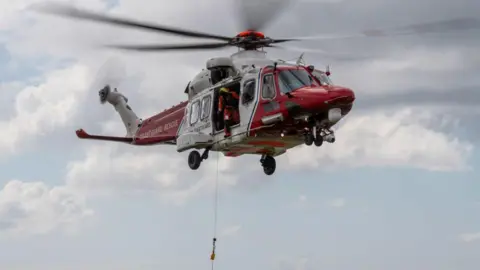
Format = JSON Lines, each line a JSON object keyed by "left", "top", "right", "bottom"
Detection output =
{"left": 67, "top": 144, "right": 253, "bottom": 204}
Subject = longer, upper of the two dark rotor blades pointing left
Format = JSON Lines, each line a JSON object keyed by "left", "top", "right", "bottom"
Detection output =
{"left": 32, "top": 4, "right": 232, "bottom": 41}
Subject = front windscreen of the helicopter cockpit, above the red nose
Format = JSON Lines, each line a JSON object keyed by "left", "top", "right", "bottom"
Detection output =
{"left": 277, "top": 67, "right": 319, "bottom": 94}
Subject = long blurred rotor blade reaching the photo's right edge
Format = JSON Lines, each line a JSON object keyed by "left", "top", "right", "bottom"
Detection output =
{"left": 278, "top": 18, "right": 480, "bottom": 40}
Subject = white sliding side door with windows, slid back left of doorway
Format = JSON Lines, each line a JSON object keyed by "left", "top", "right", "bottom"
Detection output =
{"left": 177, "top": 91, "right": 213, "bottom": 152}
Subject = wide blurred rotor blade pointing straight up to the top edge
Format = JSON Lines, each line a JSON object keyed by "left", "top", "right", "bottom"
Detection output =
{"left": 235, "top": 0, "right": 293, "bottom": 31}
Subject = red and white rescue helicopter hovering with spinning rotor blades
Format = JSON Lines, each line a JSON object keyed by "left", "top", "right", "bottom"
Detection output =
{"left": 37, "top": 2, "right": 479, "bottom": 175}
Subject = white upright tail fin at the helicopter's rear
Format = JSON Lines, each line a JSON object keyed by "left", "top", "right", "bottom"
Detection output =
{"left": 98, "top": 85, "right": 142, "bottom": 137}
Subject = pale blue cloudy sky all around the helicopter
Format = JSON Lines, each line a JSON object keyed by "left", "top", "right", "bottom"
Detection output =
{"left": 0, "top": 0, "right": 480, "bottom": 270}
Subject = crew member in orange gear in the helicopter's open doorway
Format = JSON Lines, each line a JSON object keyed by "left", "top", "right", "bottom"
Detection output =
{"left": 218, "top": 87, "right": 239, "bottom": 138}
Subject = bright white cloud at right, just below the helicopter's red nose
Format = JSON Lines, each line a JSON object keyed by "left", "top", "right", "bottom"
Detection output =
{"left": 285, "top": 108, "right": 473, "bottom": 171}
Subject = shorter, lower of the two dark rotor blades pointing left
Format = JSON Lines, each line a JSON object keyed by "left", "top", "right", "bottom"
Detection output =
{"left": 107, "top": 42, "right": 230, "bottom": 52}
